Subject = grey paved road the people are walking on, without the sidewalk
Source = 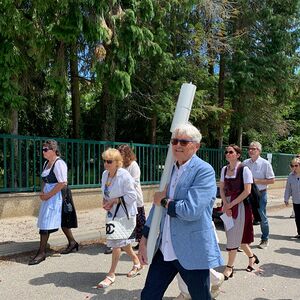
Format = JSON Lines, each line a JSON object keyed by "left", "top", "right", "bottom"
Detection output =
{"left": 0, "top": 203, "right": 300, "bottom": 300}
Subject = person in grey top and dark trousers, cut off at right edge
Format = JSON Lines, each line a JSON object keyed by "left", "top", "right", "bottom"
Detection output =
{"left": 284, "top": 158, "right": 300, "bottom": 239}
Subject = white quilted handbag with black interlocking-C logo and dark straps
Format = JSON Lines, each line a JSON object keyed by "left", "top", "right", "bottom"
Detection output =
{"left": 106, "top": 197, "right": 136, "bottom": 240}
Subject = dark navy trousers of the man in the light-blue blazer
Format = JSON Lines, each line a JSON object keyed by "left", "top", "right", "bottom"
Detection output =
{"left": 141, "top": 250, "right": 211, "bottom": 300}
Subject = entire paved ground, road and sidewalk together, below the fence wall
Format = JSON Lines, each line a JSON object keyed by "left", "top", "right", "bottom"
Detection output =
{"left": 0, "top": 190, "right": 300, "bottom": 300}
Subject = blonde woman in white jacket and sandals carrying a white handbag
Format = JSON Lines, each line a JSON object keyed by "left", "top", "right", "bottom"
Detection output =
{"left": 97, "top": 148, "right": 142, "bottom": 288}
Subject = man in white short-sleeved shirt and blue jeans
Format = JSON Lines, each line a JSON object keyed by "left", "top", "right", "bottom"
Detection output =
{"left": 243, "top": 141, "right": 275, "bottom": 249}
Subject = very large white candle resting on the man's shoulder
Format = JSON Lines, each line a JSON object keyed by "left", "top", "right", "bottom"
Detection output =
{"left": 147, "top": 83, "right": 196, "bottom": 264}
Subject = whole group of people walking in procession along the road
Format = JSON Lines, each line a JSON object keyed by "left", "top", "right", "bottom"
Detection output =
{"left": 29, "top": 124, "right": 300, "bottom": 300}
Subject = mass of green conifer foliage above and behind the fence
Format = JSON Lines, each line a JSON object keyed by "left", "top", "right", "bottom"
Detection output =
{"left": 0, "top": 0, "right": 300, "bottom": 152}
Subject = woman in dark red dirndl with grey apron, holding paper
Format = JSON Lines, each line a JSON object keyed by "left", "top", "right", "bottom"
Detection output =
{"left": 220, "top": 144, "right": 259, "bottom": 280}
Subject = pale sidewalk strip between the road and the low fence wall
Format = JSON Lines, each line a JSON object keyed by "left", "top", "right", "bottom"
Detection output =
{"left": 0, "top": 189, "right": 286, "bottom": 259}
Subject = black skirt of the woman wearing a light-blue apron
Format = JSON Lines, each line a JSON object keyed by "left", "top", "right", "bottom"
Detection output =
{"left": 61, "top": 186, "right": 78, "bottom": 228}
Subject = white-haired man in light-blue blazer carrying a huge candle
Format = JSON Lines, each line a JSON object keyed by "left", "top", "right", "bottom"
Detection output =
{"left": 139, "top": 124, "right": 223, "bottom": 300}
